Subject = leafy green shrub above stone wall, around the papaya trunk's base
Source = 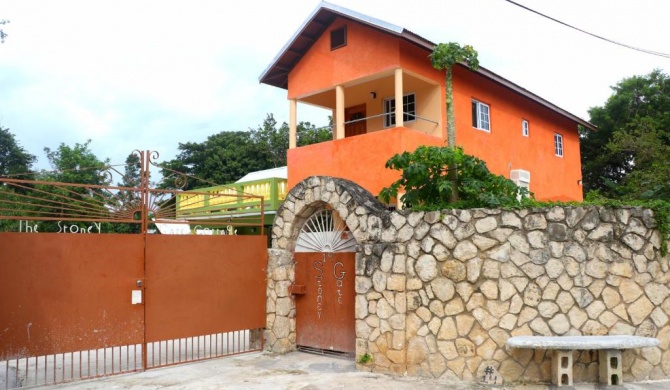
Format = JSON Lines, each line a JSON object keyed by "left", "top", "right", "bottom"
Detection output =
{"left": 380, "top": 146, "right": 530, "bottom": 210}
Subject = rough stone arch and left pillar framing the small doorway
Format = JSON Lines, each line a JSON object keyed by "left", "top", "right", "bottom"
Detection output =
{"left": 266, "top": 176, "right": 390, "bottom": 353}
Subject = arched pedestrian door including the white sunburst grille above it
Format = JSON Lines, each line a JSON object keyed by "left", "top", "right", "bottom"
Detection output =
{"left": 293, "top": 210, "right": 356, "bottom": 355}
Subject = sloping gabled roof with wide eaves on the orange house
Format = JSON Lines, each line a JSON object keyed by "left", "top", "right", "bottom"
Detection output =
{"left": 259, "top": 1, "right": 596, "bottom": 130}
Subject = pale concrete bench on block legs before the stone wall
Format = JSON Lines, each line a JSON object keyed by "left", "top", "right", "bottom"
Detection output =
{"left": 507, "top": 335, "right": 660, "bottom": 387}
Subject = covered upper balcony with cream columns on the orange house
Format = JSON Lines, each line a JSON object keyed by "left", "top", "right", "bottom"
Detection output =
{"left": 288, "top": 67, "right": 446, "bottom": 195}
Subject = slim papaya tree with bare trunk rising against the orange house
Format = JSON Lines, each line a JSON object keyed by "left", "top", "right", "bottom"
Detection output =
{"left": 430, "top": 42, "right": 479, "bottom": 202}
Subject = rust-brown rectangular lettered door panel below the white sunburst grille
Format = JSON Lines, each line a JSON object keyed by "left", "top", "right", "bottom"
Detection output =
{"left": 295, "top": 252, "right": 356, "bottom": 353}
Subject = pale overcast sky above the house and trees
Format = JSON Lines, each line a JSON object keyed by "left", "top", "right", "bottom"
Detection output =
{"left": 0, "top": 0, "right": 670, "bottom": 168}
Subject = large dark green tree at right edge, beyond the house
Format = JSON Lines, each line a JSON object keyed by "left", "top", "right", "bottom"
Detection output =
{"left": 581, "top": 70, "right": 670, "bottom": 199}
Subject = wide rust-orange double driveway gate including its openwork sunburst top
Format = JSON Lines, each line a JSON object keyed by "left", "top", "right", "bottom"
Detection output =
{"left": 0, "top": 152, "right": 267, "bottom": 390}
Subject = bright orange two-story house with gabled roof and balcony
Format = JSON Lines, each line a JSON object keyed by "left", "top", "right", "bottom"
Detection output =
{"left": 260, "top": 2, "right": 594, "bottom": 201}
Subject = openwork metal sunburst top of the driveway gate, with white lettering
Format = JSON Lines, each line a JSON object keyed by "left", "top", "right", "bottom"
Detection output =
{"left": 0, "top": 150, "right": 264, "bottom": 235}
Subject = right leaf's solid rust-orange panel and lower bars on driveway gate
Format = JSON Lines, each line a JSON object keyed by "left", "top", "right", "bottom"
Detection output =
{"left": 146, "top": 235, "right": 267, "bottom": 367}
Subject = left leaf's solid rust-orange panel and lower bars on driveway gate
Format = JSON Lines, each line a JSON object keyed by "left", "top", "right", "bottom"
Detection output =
{"left": 0, "top": 233, "right": 144, "bottom": 380}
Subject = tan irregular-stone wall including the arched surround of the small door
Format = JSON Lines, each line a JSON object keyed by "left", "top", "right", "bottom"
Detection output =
{"left": 266, "top": 177, "right": 670, "bottom": 382}
